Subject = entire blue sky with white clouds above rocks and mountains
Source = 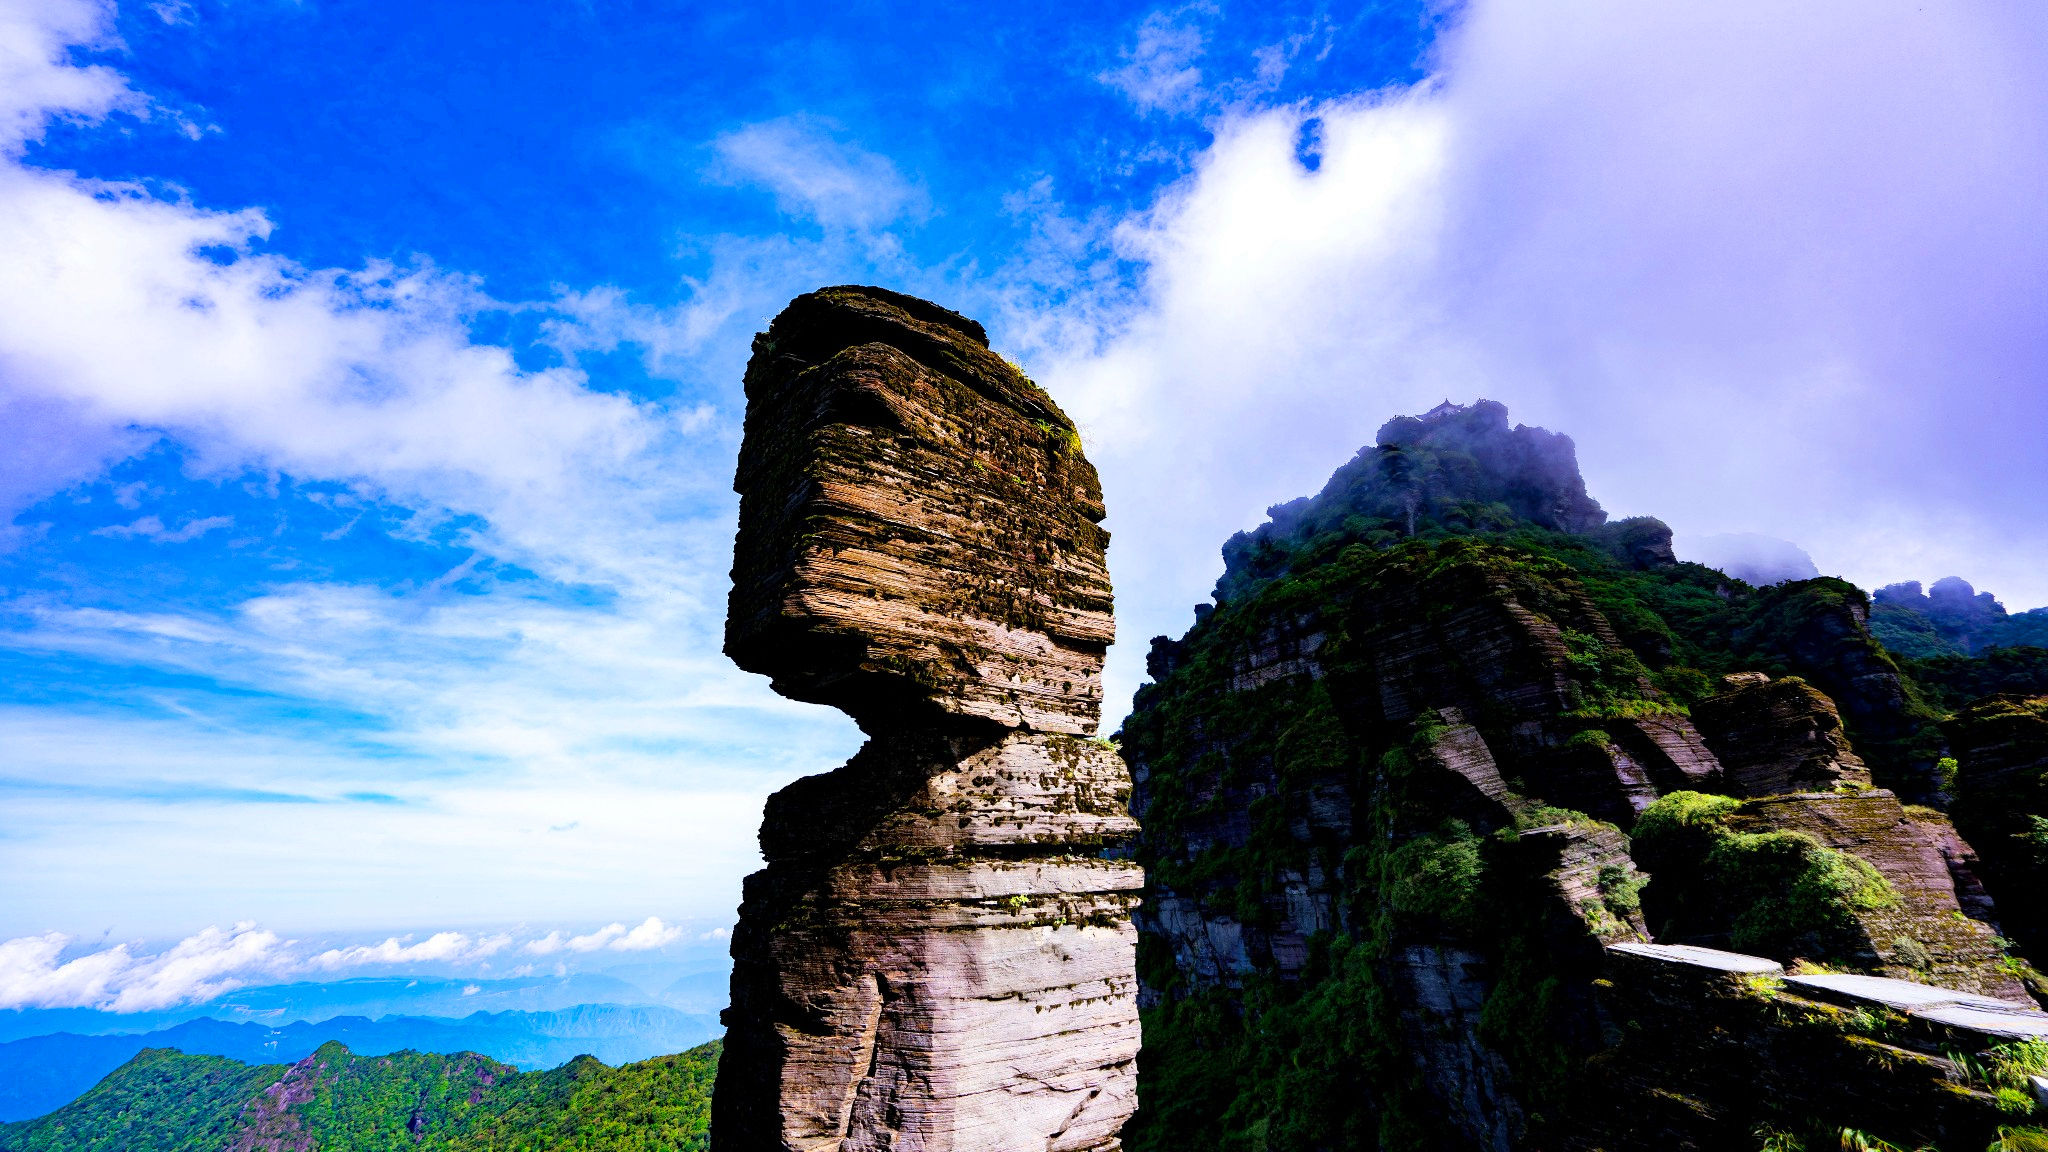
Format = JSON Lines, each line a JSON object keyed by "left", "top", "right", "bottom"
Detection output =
{"left": 0, "top": 0, "right": 2048, "bottom": 1002}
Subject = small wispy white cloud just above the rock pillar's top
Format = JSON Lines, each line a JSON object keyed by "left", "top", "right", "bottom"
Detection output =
{"left": 711, "top": 115, "right": 926, "bottom": 232}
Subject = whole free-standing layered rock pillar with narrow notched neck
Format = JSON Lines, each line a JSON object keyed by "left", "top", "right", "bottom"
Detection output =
{"left": 711, "top": 287, "right": 1143, "bottom": 1152}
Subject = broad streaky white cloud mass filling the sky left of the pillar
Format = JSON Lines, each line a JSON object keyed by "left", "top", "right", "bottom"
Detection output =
{"left": 0, "top": 0, "right": 864, "bottom": 934}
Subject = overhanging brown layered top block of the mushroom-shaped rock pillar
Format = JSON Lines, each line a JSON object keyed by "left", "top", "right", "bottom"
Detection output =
{"left": 725, "top": 289, "right": 1114, "bottom": 734}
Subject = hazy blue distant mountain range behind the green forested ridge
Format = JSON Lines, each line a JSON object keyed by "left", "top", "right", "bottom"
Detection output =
{"left": 0, "top": 1000, "right": 723, "bottom": 1121}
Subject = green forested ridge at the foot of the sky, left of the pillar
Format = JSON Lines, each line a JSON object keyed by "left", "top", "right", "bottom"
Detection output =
{"left": 0, "top": 1043, "right": 719, "bottom": 1152}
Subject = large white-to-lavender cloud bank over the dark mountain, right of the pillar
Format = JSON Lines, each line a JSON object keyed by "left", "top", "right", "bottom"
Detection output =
{"left": 1026, "top": 0, "right": 2048, "bottom": 701}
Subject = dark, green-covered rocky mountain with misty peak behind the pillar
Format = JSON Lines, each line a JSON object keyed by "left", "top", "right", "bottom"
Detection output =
{"left": 1122, "top": 406, "right": 2025, "bottom": 1152}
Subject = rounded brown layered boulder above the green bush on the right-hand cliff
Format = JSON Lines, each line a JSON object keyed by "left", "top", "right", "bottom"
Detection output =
{"left": 1692, "top": 672, "right": 1870, "bottom": 795}
